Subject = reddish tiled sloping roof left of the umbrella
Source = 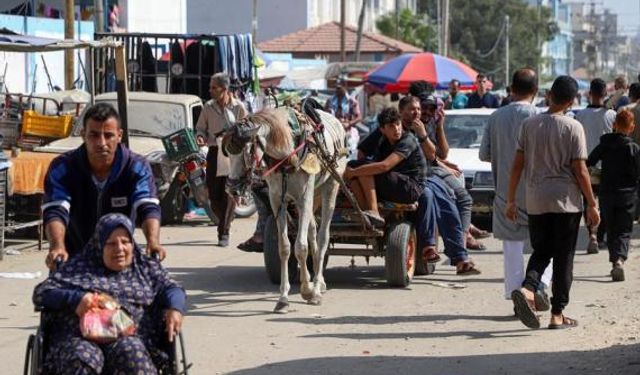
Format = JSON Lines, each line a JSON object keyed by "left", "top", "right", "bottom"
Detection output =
{"left": 258, "top": 21, "right": 422, "bottom": 54}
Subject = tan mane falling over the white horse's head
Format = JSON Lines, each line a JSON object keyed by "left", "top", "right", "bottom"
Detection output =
{"left": 251, "top": 109, "right": 293, "bottom": 158}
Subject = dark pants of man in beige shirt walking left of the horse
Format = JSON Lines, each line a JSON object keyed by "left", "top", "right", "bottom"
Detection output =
{"left": 207, "top": 146, "right": 236, "bottom": 239}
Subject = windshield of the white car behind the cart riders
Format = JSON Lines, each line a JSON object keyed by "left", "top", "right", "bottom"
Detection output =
{"left": 444, "top": 114, "right": 489, "bottom": 148}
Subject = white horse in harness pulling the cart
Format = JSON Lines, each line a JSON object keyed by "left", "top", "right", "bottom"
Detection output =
{"left": 223, "top": 107, "right": 347, "bottom": 313}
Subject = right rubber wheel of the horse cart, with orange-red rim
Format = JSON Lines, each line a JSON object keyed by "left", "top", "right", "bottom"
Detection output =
{"left": 385, "top": 221, "right": 417, "bottom": 287}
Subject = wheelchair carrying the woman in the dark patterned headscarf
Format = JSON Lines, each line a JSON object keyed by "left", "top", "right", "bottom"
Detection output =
{"left": 24, "top": 306, "right": 192, "bottom": 375}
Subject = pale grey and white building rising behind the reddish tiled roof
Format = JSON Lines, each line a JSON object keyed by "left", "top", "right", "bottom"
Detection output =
{"left": 186, "top": 0, "right": 417, "bottom": 42}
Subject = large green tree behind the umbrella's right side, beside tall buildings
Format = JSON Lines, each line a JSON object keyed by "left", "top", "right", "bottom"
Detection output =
{"left": 419, "top": 0, "right": 558, "bottom": 86}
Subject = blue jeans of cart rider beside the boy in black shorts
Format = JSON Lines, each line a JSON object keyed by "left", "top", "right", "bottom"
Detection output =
{"left": 416, "top": 176, "right": 468, "bottom": 265}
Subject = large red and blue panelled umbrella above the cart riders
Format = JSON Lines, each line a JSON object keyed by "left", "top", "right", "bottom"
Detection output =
{"left": 366, "top": 52, "right": 490, "bottom": 92}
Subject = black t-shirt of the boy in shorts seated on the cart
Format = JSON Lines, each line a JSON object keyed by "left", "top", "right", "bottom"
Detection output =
{"left": 358, "top": 129, "right": 427, "bottom": 183}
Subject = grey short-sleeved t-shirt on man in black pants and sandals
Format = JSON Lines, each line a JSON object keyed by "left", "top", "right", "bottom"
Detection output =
{"left": 518, "top": 113, "right": 587, "bottom": 215}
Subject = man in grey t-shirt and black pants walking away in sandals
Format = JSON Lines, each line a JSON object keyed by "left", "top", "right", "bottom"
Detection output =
{"left": 506, "top": 76, "right": 600, "bottom": 329}
